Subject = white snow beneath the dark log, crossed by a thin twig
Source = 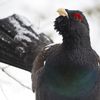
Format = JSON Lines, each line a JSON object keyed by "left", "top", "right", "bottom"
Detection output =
{"left": 0, "top": 63, "right": 35, "bottom": 100}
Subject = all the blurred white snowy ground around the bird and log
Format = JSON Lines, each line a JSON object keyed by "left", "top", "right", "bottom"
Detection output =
{"left": 0, "top": 0, "right": 100, "bottom": 100}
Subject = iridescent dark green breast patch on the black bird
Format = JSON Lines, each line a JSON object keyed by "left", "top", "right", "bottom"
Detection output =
{"left": 46, "top": 67, "right": 96, "bottom": 97}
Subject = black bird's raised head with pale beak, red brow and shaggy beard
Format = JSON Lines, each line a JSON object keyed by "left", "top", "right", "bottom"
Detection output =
{"left": 54, "top": 8, "right": 89, "bottom": 37}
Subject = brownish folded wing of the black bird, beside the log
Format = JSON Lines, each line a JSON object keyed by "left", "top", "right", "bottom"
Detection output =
{"left": 31, "top": 44, "right": 60, "bottom": 92}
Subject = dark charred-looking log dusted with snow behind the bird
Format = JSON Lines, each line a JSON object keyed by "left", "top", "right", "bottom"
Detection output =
{"left": 0, "top": 15, "right": 52, "bottom": 71}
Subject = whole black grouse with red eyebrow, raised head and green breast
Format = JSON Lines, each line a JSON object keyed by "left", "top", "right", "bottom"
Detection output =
{"left": 32, "top": 8, "right": 100, "bottom": 100}
